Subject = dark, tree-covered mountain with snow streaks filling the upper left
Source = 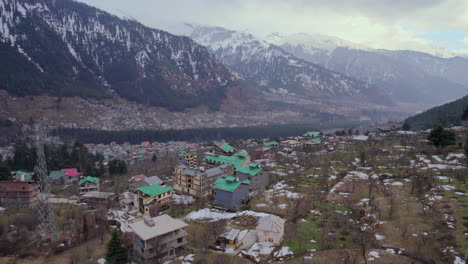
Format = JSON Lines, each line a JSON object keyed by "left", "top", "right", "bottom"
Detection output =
{"left": 0, "top": 0, "right": 237, "bottom": 110}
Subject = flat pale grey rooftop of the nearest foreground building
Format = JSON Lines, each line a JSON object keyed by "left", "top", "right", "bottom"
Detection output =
{"left": 129, "top": 215, "right": 187, "bottom": 240}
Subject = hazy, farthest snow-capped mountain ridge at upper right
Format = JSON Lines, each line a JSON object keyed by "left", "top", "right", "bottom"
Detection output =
{"left": 266, "top": 33, "right": 468, "bottom": 104}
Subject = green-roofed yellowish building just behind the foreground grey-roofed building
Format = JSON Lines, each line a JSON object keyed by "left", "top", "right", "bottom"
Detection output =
{"left": 134, "top": 184, "right": 174, "bottom": 215}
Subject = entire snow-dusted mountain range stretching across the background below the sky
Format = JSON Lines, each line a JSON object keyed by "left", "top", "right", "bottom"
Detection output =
{"left": 0, "top": 0, "right": 468, "bottom": 129}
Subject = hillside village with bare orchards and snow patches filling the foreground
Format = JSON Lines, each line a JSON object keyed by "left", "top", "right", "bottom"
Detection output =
{"left": 0, "top": 127, "right": 468, "bottom": 264}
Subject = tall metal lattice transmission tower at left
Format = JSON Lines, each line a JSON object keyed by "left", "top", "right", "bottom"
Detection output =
{"left": 34, "top": 124, "right": 57, "bottom": 240}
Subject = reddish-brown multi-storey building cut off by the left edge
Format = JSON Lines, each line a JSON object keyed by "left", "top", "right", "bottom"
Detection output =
{"left": 0, "top": 180, "right": 40, "bottom": 208}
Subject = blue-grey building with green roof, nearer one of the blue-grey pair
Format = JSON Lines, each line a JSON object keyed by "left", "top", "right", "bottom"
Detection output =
{"left": 213, "top": 176, "right": 250, "bottom": 209}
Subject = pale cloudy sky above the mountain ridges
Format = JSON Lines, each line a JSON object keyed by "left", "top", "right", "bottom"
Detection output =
{"left": 80, "top": 0, "right": 468, "bottom": 56}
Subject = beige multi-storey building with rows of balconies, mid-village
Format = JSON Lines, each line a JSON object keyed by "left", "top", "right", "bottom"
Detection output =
{"left": 174, "top": 164, "right": 233, "bottom": 197}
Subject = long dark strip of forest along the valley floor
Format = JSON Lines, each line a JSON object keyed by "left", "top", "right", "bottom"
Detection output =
{"left": 52, "top": 121, "right": 362, "bottom": 144}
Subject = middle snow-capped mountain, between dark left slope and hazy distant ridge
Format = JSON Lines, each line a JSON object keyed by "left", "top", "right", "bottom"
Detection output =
{"left": 190, "top": 26, "right": 389, "bottom": 103}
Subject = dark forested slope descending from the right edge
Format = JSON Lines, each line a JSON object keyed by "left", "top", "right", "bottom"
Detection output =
{"left": 405, "top": 96, "right": 468, "bottom": 130}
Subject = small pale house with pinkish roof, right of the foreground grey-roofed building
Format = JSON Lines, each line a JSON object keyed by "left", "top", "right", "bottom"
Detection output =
{"left": 256, "top": 215, "right": 285, "bottom": 245}
